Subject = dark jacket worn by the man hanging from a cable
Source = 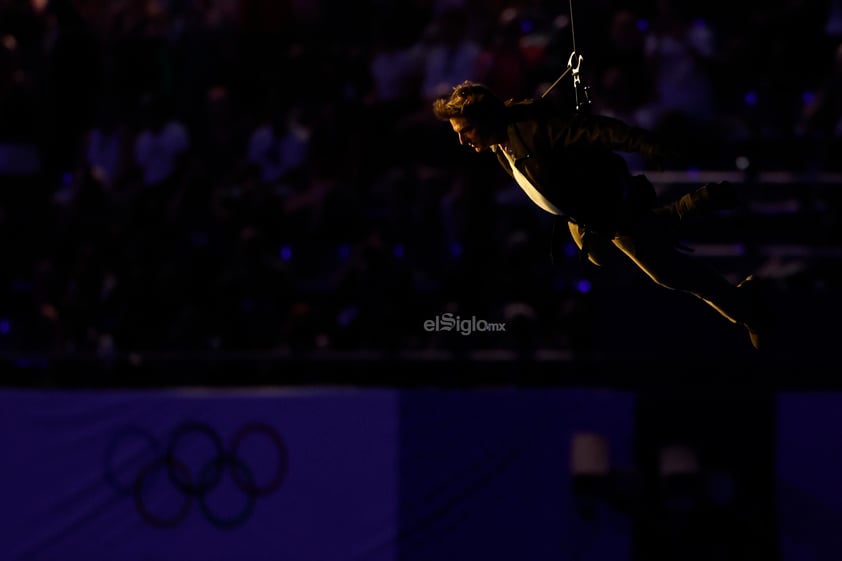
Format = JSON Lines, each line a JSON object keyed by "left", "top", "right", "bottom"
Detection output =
{"left": 497, "top": 99, "right": 660, "bottom": 235}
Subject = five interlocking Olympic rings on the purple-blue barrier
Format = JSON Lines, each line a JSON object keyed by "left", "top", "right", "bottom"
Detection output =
{"left": 105, "top": 421, "right": 289, "bottom": 528}
